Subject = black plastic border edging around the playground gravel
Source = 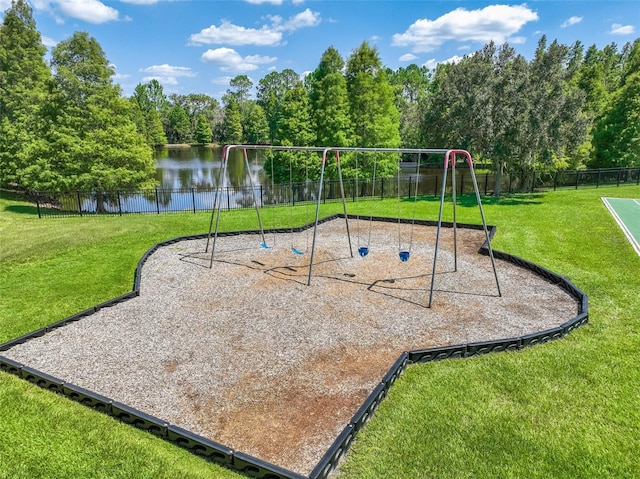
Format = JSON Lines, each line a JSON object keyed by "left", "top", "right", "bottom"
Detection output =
{"left": 0, "top": 214, "right": 589, "bottom": 479}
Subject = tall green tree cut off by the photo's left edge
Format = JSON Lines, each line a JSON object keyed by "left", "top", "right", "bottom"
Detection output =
{"left": 0, "top": 0, "right": 51, "bottom": 186}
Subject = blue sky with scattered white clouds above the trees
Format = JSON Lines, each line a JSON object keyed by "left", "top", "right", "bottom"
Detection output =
{"left": 0, "top": 0, "right": 640, "bottom": 98}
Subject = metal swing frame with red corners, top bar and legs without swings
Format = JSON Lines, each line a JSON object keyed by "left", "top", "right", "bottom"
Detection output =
{"left": 205, "top": 145, "right": 502, "bottom": 308}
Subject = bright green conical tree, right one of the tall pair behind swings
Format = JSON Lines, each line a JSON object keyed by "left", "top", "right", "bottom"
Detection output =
{"left": 346, "top": 42, "right": 400, "bottom": 177}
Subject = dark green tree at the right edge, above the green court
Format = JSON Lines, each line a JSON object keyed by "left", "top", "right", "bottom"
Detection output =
{"left": 590, "top": 71, "right": 640, "bottom": 168}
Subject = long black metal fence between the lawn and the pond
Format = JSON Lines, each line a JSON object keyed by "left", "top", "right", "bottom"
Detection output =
{"left": 32, "top": 167, "right": 640, "bottom": 218}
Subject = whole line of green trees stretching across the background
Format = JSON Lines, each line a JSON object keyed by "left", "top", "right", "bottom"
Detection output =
{"left": 0, "top": 0, "right": 640, "bottom": 196}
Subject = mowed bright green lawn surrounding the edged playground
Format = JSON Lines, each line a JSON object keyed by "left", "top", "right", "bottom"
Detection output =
{"left": 0, "top": 186, "right": 640, "bottom": 479}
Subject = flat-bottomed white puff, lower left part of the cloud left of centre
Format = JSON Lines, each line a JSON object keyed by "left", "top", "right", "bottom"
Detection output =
{"left": 189, "top": 21, "right": 282, "bottom": 46}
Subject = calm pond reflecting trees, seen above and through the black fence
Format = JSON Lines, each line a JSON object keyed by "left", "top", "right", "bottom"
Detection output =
{"left": 74, "top": 146, "right": 488, "bottom": 214}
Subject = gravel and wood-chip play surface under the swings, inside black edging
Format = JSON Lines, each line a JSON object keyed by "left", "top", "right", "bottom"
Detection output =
{"left": 4, "top": 219, "right": 578, "bottom": 474}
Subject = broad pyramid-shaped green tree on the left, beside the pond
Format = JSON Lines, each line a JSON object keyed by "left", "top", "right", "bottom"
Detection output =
{"left": 24, "top": 32, "right": 155, "bottom": 202}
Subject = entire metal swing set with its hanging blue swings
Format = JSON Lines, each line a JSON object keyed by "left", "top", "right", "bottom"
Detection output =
{"left": 205, "top": 145, "right": 502, "bottom": 307}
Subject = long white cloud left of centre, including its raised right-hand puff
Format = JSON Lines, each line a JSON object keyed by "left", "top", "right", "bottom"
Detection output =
{"left": 189, "top": 8, "right": 322, "bottom": 47}
